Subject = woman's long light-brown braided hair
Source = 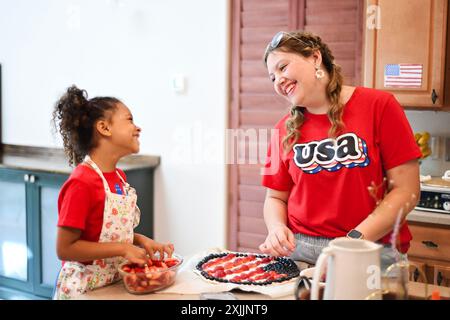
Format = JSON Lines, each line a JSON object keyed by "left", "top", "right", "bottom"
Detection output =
{"left": 264, "top": 31, "right": 344, "bottom": 152}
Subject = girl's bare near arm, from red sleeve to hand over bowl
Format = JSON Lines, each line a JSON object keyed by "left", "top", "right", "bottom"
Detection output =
{"left": 56, "top": 227, "right": 147, "bottom": 264}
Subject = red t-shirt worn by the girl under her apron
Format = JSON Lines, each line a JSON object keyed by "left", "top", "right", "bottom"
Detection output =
{"left": 58, "top": 165, "right": 126, "bottom": 262}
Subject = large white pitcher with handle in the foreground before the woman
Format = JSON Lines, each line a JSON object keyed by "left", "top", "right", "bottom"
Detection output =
{"left": 311, "top": 238, "right": 382, "bottom": 300}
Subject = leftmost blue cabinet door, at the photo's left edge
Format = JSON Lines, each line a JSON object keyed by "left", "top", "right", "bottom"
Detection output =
{"left": 0, "top": 169, "right": 32, "bottom": 291}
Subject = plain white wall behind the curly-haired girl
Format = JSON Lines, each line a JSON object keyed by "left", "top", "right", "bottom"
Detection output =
{"left": 0, "top": 0, "right": 229, "bottom": 254}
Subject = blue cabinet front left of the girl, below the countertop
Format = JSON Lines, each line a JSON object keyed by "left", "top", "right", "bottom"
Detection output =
{"left": 0, "top": 168, "right": 68, "bottom": 298}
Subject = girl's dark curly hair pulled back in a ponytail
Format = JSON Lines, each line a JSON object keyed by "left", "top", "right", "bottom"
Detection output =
{"left": 52, "top": 85, "right": 120, "bottom": 165}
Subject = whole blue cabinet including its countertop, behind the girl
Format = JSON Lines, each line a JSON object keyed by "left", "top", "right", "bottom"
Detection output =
{"left": 0, "top": 145, "right": 160, "bottom": 299}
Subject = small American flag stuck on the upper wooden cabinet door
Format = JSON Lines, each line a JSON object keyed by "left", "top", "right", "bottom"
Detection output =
{"left": 384, "top": 63, "right": 422, "bottom": 88}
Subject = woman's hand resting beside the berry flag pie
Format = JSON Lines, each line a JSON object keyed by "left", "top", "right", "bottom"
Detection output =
{"left": 259, "top": 224, "right": 295, "bottom": 256}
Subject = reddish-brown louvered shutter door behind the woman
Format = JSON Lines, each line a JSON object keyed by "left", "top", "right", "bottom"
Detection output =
{"left": 227, "top": 0, "right": 362, "bottom": 252}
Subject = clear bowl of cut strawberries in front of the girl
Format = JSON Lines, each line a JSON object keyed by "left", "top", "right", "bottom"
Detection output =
{"left": 119, "top": 253, "right": 183, "bottom": 294}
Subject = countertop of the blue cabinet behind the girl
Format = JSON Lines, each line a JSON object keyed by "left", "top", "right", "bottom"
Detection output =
{"left": 0, "top": 145, "right": 160, "bottom": 174}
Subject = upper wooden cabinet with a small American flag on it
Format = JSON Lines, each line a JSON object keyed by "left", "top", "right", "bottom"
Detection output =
{"left": 363, "top": 0, "right": 448, "bottom": 107}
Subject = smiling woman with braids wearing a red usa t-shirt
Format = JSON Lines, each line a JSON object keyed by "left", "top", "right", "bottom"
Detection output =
{"left": 260, "top": 32, "right": 421, "bottom": 269}
